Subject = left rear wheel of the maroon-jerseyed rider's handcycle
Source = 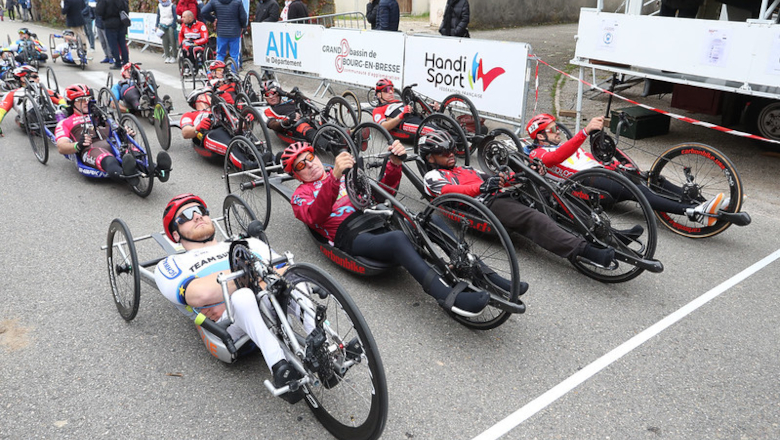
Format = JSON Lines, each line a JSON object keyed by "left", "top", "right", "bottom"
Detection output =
{"left": 224, "top": 136, "right": 271, "bottom": 229}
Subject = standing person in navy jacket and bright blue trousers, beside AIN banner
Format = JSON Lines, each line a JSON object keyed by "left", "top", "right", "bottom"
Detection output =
{"left": 200, "top": 0, "right": 247, "bottom": 67}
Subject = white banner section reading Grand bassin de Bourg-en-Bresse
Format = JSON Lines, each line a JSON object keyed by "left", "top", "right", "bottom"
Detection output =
{"left": 320, "top": 29, "right": 404, "bottom": 87}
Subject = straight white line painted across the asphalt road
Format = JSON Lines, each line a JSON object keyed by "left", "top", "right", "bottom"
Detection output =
{"left": 474, "top": 249, "right": 780, "bottom": 440}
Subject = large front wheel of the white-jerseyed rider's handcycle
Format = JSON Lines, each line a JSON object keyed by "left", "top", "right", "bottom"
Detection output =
{"left": 284, "top": 263, "right": 388, "bottom": 440}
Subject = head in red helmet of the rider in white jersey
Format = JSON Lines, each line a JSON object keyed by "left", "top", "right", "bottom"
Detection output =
{"left": 163, "top": 194, "right": 215, "bottom": 247}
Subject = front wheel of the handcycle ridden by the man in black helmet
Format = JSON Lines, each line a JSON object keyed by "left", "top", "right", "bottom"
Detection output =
{"left": 558, "top": 168, "right": 658, "bottom": 283}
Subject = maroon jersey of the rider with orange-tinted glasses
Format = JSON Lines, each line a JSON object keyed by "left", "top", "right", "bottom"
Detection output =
{"left": 290, "top": 161, "right": 401, "bottom": 245}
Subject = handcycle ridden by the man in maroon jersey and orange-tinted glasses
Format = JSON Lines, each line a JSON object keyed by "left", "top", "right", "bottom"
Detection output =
{"left": 225, "top": 122, "right": 525, "bottom": 330}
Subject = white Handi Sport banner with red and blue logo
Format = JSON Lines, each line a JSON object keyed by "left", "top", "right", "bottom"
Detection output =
{"left": 403, "top": 35, "right": 529, "bottom": 118}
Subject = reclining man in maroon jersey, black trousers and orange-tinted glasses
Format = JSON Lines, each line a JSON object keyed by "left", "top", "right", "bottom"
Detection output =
{"left": 282, "top": 141, "right": 496, "bottom": 313}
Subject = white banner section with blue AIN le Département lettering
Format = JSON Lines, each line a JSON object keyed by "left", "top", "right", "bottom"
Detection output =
{"left": 252, "top": 23, "right": 324, "bottom": 75}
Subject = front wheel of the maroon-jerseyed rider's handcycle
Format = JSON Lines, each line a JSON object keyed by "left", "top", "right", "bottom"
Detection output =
{"left": 421, "top": 194, "right": 521, "bottom": 330}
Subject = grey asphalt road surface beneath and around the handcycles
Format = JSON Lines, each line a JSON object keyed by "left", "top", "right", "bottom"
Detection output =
{"left": 0, "top": 21, "right": 780, "bottom": 439}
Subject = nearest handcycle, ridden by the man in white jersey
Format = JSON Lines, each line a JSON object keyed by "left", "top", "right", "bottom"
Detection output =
{"left": 102, "top": 195, "right": 388, "bottom": 440}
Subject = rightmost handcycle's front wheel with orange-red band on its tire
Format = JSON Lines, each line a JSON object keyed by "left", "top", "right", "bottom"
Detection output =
{"left": 648, "top": 143, "right": 743, "bottom": 238}
